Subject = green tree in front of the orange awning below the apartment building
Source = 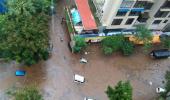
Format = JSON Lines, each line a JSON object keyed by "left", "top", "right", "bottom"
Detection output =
{"left": 135, "top": 25, "right": 153, "bottom": 51}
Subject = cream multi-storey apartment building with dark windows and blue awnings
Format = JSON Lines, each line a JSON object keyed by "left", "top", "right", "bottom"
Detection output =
{"left": 92, "top": 0, "right": 170, "bottom": 30}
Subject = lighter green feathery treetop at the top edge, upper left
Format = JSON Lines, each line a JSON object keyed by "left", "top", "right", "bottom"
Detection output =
{"left": 7, "top": 0, "right": 51, "bottom": 16}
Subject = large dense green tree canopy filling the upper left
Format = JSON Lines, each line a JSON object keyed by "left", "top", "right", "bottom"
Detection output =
{"left": 0, "top": 0, "right": 50, "bottom": 65}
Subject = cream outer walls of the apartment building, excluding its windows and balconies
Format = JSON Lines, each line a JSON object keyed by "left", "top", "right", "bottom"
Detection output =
{"left": 92, "top": 0, "right": 170, "bottom": 30}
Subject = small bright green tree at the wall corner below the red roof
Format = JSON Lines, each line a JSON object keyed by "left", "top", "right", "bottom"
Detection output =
{"left": 73, "top": 36, "right": 87, "bottom": 53}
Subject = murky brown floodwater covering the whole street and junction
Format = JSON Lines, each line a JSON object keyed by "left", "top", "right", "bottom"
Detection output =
{"left": 0, "top": 1, "right": 170, "bottom": 100}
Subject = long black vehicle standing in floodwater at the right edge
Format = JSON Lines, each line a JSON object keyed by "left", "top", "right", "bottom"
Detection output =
{"left": 150, "top": 49, "right": 170, "bottom": 59}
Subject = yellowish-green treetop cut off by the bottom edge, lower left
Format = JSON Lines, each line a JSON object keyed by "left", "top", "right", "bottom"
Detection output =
{"left": 8, "top": 86, "right": 43, "bottom": 100}
